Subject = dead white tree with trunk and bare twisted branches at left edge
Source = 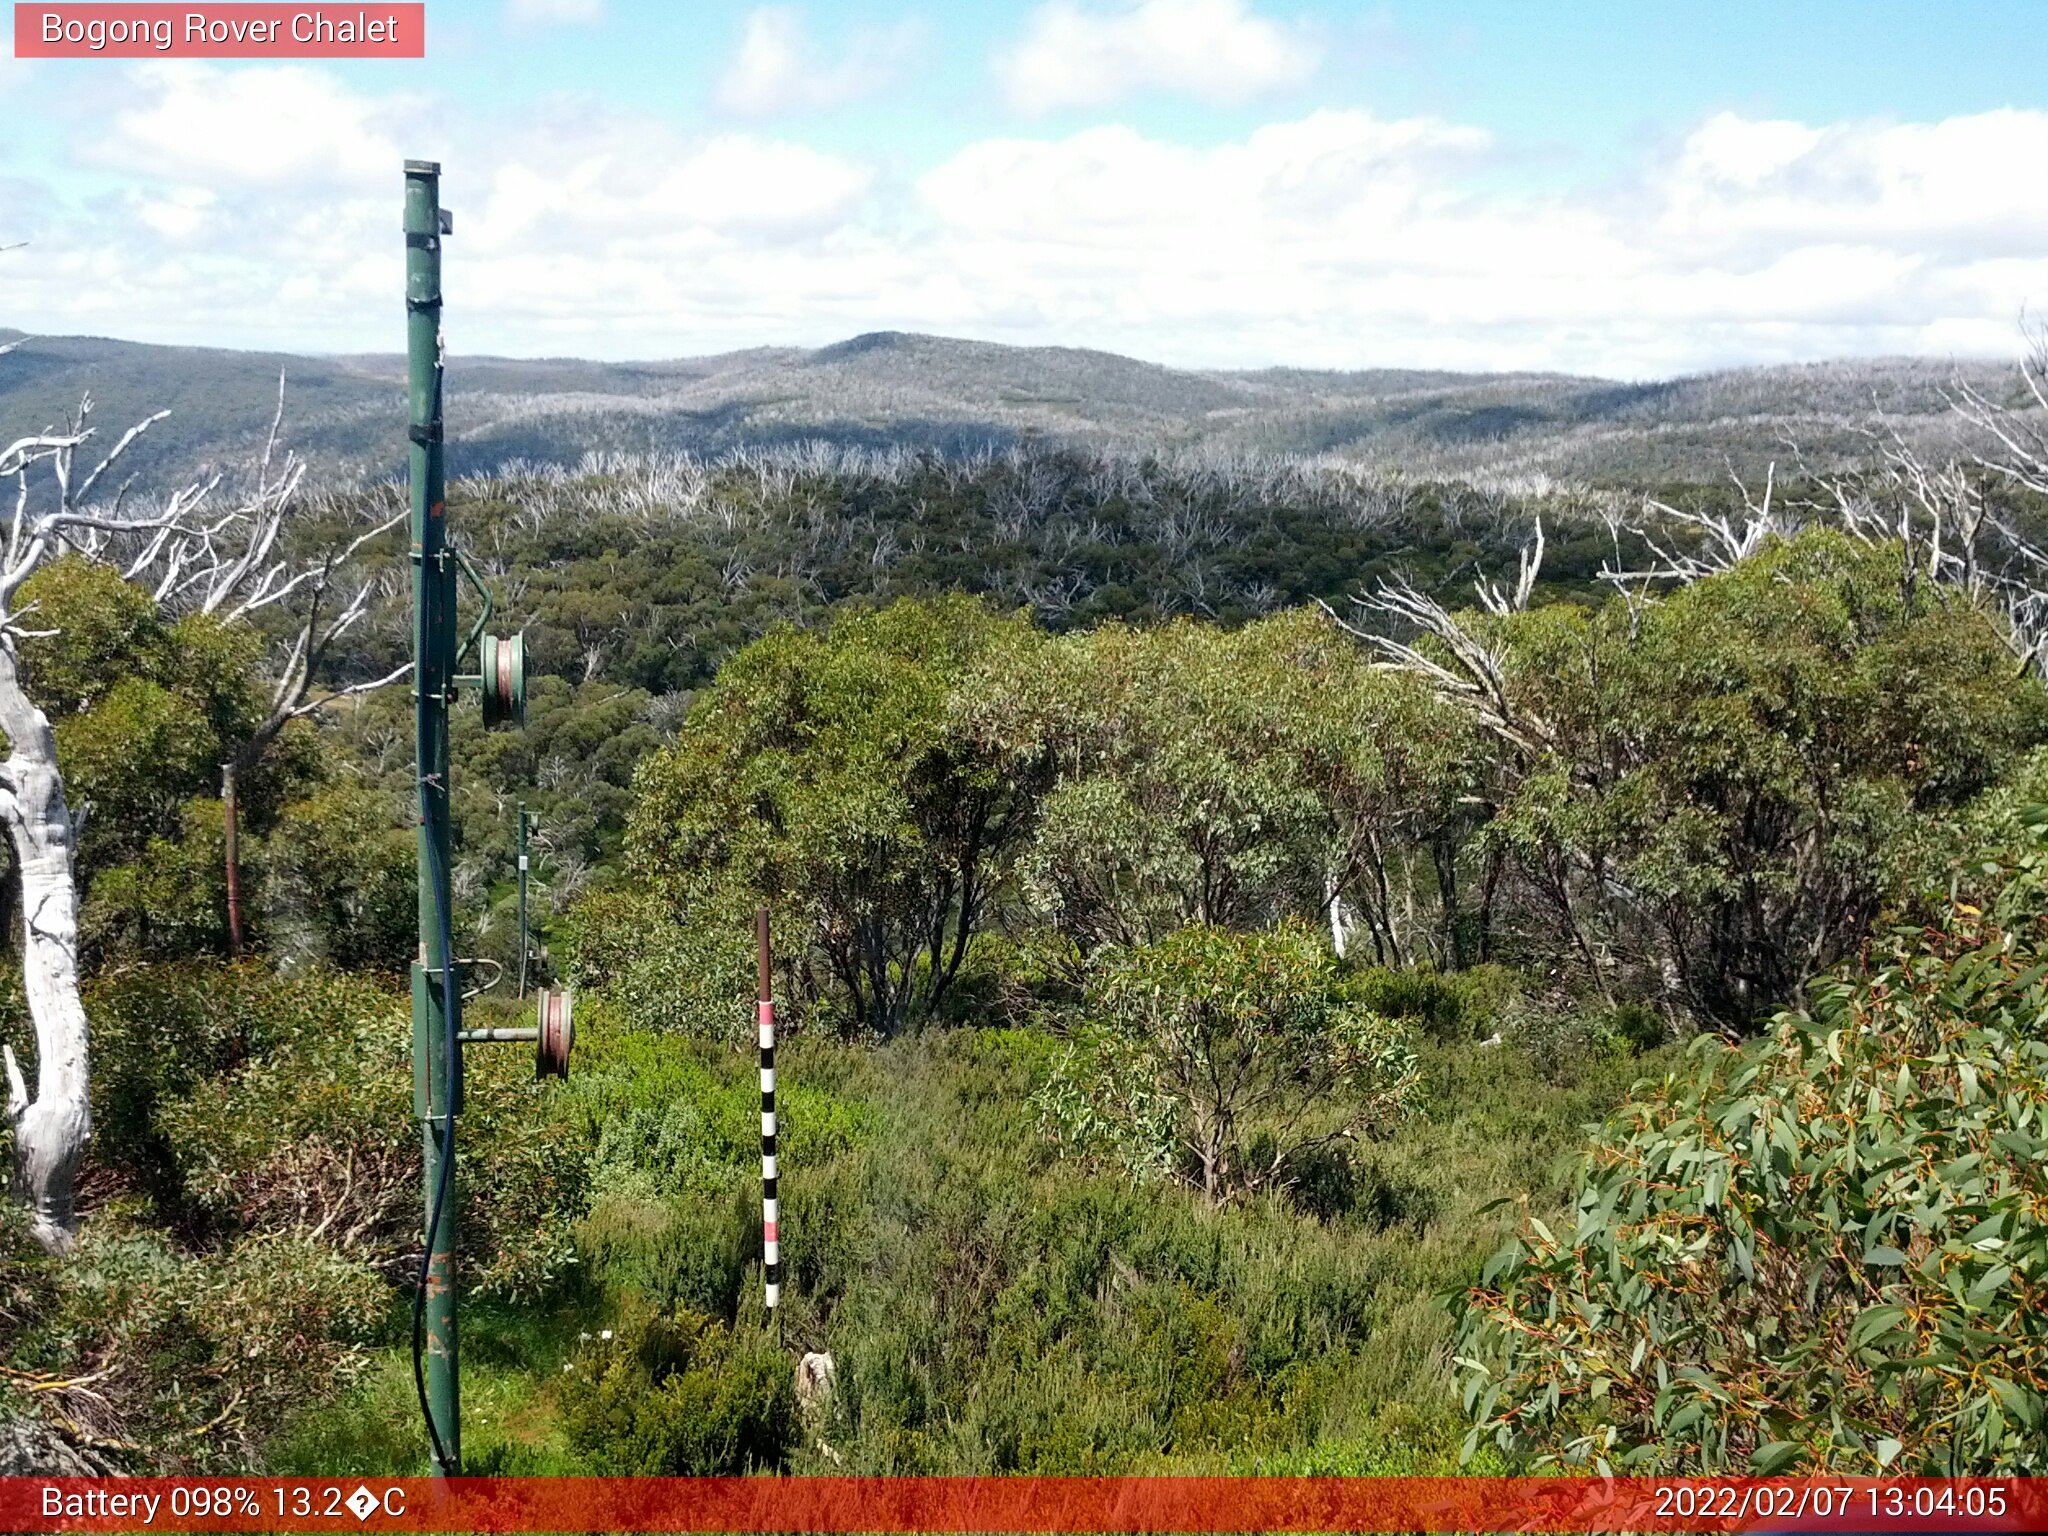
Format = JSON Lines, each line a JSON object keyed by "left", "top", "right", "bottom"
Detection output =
{"left": 0, "top": 382, "right": 403, "bottom": 1251}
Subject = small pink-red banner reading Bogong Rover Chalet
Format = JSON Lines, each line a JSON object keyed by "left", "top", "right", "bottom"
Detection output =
{"left": 14, "top": 0, "right": 426, "bottom": 59}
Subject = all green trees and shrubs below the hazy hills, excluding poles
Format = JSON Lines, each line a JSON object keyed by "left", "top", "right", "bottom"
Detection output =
{"left": 0, "top": 430, "right": 2048, "bottom": 1473}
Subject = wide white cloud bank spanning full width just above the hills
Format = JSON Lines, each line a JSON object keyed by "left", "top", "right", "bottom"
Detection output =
{"left": 0, "top": 66, "right": 2048, "bottom": 377}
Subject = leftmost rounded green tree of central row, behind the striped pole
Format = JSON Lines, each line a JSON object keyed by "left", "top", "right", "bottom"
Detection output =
{"left": 627, "top": 598, "right": 1038, "bottom": 1034}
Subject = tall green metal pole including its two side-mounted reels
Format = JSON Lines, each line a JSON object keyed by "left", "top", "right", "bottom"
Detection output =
{"left": 406, "top": 160, "right": 573, "bottom": 1477}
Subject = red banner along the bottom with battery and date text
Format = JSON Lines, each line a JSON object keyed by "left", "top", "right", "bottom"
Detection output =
{"left": 0, "top": 1477, "right": 2048, "bottom": 1532}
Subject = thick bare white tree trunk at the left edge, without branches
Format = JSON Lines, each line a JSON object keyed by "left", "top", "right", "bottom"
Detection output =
{"left": 0, "top": 637, "right": 92, "bottom": 1251}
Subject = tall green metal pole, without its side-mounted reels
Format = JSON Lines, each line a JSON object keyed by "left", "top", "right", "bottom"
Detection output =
{"left": 406, "top": 160, "right": 463, "bottom": 1477}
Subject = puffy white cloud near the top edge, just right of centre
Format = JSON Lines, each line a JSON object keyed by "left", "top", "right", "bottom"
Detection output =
{"left": 997, "top": 0, "right": 1323, "bottom": 113}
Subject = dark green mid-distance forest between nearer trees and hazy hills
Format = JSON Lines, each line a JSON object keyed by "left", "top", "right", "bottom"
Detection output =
{"left": 291, "top": 449, "right": 1646, "bottom": 974}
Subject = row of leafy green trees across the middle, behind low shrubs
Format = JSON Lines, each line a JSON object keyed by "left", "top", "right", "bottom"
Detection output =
{"left": 602, "top": 532, "right": 2048, "bottom": 1034}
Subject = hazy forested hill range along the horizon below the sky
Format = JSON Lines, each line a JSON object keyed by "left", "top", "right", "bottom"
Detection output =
{"left": 0, "top": 330, "right": 2009, "bottom": 483}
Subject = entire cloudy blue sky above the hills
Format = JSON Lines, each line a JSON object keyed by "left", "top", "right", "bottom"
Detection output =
{"left": 0, "top": 0, "right": 2048, "bottom": 379}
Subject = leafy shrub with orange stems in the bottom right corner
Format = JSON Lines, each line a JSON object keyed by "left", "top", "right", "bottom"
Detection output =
{"left": 1462, "top": 823, "right": 2048, "bottom": 1475}
